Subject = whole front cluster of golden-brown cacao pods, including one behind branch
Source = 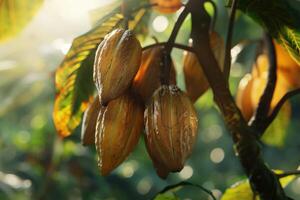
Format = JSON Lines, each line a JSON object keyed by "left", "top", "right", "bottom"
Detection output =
{"left": 82, "top": 25, "right": 224, "bottom": 178}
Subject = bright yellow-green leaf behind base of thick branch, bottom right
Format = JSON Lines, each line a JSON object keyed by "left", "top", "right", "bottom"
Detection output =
{"left": 221, "top": 170, "right": 296, "bottom": 200}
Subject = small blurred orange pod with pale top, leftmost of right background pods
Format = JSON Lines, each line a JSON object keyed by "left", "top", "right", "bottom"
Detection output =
{"left": 236, "top": 74, "right": 254, "bottom": 121}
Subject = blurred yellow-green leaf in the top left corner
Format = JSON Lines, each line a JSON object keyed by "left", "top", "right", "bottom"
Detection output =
{"left": 0, "top": 0, "right": 43, "bottom": 42}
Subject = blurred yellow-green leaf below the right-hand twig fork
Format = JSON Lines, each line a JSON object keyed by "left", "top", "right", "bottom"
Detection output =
{"left": 262, "top": 103, "right": 291, "bottom": 147}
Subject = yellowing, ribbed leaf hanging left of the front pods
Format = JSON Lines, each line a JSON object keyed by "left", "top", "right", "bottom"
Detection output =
{"left": 53, "top": 8, "right": 123, "bottom": 137}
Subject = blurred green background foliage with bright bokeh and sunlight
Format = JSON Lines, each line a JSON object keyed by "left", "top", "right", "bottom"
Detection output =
{"left": 0, "top": 0, "right": 300, "bottom": 200}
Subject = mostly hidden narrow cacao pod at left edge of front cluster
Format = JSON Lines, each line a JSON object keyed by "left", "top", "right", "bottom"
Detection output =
{"left": 81, "top": 95, "right": 103, "bottom": 145}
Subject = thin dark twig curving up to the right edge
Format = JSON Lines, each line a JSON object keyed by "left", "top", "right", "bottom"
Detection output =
{"left": 262, "top": 88, "right": 300, "bottom": 131}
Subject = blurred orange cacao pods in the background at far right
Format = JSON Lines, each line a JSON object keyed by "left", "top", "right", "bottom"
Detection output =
{"left": 236, "top": 42, "right": 300, "bottom": 121}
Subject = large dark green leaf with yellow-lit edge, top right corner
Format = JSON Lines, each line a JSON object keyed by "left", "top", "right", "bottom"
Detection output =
{"left": 238, "top": 0, "right": 300, "bottom": 64}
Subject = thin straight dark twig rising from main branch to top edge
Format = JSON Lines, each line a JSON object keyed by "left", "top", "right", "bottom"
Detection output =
{"left": 224, "top": 0, "right": 238, "bottom": 83}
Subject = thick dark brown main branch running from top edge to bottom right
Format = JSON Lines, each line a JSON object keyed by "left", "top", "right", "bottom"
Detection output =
{"left": 186, "top": 0, "right": 288, "bottom": 200}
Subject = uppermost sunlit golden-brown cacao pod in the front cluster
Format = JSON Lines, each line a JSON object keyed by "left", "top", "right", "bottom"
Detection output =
{"left": 94, "top": 29, "right": 142, "bottom": 105}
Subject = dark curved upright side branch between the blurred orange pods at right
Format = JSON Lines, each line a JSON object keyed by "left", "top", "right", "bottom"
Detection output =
{"left": 251, "top": 33, "right": 277, "bottom": 134}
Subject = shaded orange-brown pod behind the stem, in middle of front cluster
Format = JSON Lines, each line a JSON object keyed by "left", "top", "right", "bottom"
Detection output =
{"left": 132, "top": 46, "right": 176, "bottom": 103}
